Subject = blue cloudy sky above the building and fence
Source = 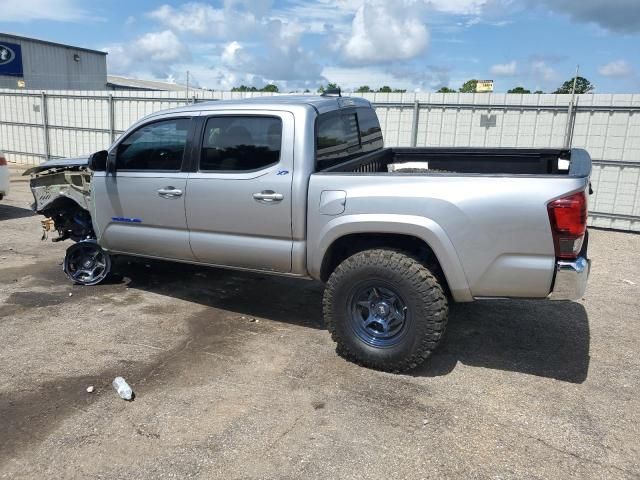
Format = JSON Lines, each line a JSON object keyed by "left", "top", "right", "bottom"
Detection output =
{"left": 0, "top": 0, "right": 640, "bottom": 93}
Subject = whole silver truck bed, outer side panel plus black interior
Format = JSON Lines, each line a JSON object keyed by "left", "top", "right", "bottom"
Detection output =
{"left": 307, "top": 148, "right": 591, "bottom": 301}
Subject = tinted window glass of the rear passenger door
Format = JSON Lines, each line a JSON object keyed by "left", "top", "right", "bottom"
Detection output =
{"left": 200, "top": 116, "right": 282, "bottom": 172}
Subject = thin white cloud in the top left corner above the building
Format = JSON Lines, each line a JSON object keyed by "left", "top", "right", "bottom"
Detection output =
{"left": 0, "top": 0, "right": 90, "bottom": 22}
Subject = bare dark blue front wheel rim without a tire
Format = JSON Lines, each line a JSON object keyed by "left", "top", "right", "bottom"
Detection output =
{"left": 63, "top": 240, "right": 111, "bottom": 285}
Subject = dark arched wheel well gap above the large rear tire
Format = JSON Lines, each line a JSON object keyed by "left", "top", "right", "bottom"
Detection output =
{"left": 320, "top": 233, "right": 449, "bottom": 294}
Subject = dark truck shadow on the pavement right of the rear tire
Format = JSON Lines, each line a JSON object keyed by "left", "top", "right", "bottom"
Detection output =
{"left": 411, "top": 300, "right": 590, "bottom": 383}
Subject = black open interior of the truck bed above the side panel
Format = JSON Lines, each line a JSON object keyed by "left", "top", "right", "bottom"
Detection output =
{"left": 322, "top": 147, "right": 591, "bottom": 177}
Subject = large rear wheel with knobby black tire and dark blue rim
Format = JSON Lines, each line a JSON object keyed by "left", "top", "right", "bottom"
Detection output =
{"left": 323, "top": 249, "right": 448, "bottom": 372}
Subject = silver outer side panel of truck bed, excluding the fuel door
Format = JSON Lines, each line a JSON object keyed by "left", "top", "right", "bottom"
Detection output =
{"left": 307, "top": 173, "right": 587, "bottom": 301}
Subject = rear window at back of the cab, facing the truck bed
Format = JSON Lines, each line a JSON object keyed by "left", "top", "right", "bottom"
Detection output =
{"left": 316, "top": 108, "right": 383, "bottom": 170}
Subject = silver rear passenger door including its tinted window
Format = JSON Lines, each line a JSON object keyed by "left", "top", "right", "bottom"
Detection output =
{"left": 186, "top": 111, "right": 294, "bottom": 273}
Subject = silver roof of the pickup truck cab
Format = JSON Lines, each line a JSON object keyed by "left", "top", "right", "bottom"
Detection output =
{"left": 154, "top": 95, "right": 371, "bottom": 114}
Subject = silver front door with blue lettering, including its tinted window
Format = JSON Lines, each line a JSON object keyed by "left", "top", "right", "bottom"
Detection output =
{"left": 92, "top": 117, "right": 193, "bottom": 260}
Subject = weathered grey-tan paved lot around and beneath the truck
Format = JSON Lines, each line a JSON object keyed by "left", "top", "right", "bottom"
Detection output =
{"left": 0, "top": 167, "right": 640, "bottom": 479}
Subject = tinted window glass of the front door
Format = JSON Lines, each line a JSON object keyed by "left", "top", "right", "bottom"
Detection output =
{"left": 116, "top": 118, "right": 191, "bottom": 171}
